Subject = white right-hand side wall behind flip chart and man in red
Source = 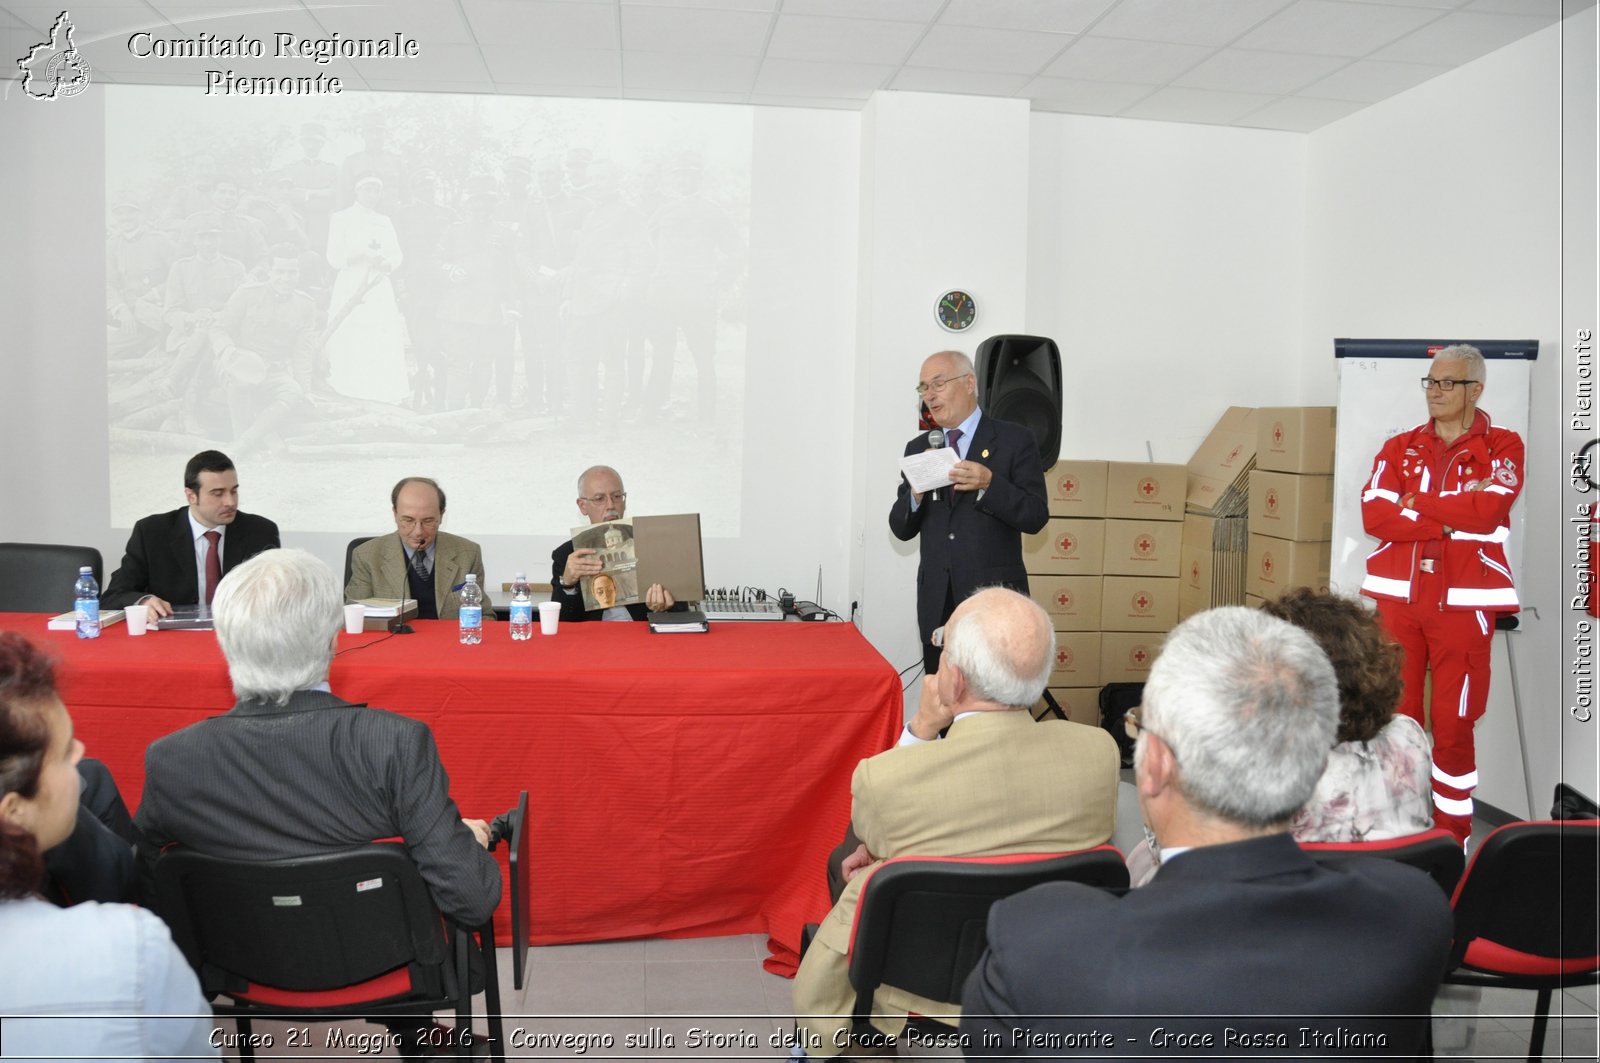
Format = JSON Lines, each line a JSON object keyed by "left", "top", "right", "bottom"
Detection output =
{"left": 1301, "top": 10, "right": 1597, "bottom": 815}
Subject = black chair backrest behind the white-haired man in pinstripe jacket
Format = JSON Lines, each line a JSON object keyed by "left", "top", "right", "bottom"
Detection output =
{"left": 155, "top": 844, "right": 454, "bottom": 1004}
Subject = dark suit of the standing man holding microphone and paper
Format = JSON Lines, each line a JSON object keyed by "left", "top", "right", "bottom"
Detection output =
{"left": 890, "top": 413, "right": 1050, "bottom": 671}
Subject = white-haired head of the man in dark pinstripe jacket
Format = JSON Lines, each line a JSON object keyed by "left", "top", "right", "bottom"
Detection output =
{"left": 211, "top": 549, "right": 344, "bottom": 704}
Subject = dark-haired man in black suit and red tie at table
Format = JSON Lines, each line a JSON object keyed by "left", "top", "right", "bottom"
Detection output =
{"left": 101, "top": 450, "right": 278, "bottom": 620}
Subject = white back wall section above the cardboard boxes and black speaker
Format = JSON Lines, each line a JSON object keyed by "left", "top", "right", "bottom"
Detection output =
{"left": 1027, "top": 114, "right": 1306, "bottom": 463}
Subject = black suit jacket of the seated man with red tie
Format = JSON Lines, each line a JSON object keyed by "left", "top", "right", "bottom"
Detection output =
{"left": 101, "top": 506, "right": 282, "bottom": 608}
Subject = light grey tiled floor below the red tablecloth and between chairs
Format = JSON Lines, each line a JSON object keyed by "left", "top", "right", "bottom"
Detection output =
{"left": 212, "top": 935, "right": 1600, "bottom": 1063}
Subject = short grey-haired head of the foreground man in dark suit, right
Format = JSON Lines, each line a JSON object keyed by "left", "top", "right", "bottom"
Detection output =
{"left": 1142, "top": 607, "right": 1339, "bottom": 829}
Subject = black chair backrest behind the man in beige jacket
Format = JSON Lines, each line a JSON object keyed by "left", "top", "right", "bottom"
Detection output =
{"left": 850, "top": 845, "right": 1128, "bottom": 1018}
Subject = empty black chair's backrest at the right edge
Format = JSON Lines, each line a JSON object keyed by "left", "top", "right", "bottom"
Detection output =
{"left": 1451, "top": 820, "right": 1600, "bottom": 967}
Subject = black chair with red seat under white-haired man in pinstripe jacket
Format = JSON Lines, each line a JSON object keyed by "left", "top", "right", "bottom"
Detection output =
{"left": 154, "top": 842, "right": 504, "bottom": 1060}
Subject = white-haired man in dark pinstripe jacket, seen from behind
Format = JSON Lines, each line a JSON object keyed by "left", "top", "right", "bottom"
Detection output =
{"left": 134, "top": 549, "right": 501, "bottom": 1056}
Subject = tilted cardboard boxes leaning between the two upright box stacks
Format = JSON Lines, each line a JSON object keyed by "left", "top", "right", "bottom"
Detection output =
{"left": 1178, "top": 407, "right": 1256, "bottom": 620}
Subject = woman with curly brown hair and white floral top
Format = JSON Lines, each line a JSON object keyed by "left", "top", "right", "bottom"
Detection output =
{"left": 1261, "top": 588, "right": 1434, "bottom": 842}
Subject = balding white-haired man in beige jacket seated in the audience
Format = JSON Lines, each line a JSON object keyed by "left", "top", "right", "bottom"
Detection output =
{"left": 794, "top": 588, "right": 1117, "bottom": 1057}
